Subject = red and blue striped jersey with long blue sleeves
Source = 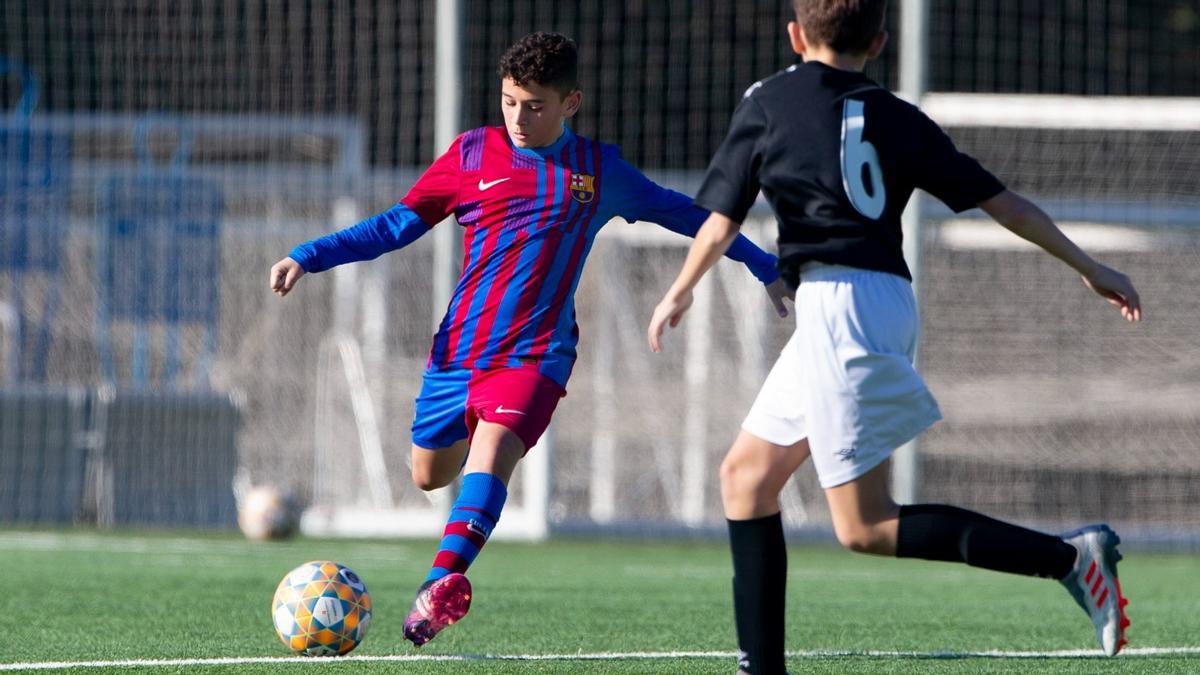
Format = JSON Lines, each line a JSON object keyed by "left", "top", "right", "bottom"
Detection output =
{"left": 292, "top": 126, "right": 779, "bottom": 387}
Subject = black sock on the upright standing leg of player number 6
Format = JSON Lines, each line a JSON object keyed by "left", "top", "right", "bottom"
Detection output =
{"left": 728, "top": 513, "right": 787, "bottom": 675}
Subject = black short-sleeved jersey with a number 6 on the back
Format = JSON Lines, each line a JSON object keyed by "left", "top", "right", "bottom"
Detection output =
{"left": 696, "top": 61, "right": 1004, "bottom": 287}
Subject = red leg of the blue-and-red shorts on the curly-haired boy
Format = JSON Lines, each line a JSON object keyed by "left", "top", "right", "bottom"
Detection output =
{"left": 467, "top": 365, "right": 566, "bottom": 452}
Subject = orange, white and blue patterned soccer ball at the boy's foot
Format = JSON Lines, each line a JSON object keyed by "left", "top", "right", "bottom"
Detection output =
{"left": 271, "top": 560, "right": 371, "bottom": 656}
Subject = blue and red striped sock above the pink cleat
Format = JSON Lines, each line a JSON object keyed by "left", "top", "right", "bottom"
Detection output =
{"left": 425, "top": 473, "right": 509, "bottom": 585}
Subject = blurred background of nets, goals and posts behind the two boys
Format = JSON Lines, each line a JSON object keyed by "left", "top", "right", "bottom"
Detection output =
{"left": 0, "top": 0, "right": 1200, "bottom": 546}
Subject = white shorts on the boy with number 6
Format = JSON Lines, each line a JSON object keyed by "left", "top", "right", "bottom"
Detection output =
{"left": 742, "top": 263, "right": 942, "bottom": 488}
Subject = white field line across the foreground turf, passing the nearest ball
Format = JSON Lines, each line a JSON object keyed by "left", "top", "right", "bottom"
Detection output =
{"left": 0, "top": 646, "right": 1200, "bottom": 670}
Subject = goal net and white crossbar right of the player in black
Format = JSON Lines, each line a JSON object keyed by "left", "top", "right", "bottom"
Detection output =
{"left": 920, "top": 95, "right": 1200, "bottom": 537}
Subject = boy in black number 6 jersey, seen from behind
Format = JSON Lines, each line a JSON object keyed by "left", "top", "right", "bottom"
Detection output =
{"left": 648, "top": 0, "right": 1141, "bottom": 675}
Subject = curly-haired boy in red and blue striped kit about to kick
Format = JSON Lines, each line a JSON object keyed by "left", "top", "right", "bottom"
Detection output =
{"left": 270, "top": 32, "right": 790, "bottom": 646}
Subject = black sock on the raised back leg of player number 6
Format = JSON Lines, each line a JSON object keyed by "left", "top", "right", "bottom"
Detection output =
{"left": 896, "top": 504, "right": 1076, "bottom": 579}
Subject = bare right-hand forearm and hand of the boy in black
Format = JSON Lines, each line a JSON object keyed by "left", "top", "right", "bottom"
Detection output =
{"left": 979, "top": 190, "right": 1141, "bottom": 321}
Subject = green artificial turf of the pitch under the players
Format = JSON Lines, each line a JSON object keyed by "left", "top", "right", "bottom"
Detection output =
{"left": 0, "top": 530, "right": 1200, "bottom": 674}
